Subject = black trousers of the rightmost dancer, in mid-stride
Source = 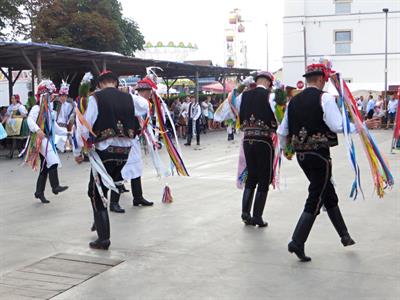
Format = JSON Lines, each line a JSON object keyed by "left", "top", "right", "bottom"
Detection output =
{"left": 297, "top": 149, "right": 339, "bottom": 215}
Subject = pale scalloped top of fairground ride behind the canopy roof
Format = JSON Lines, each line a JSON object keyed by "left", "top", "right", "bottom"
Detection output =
{"left": 135, "top": 41, "right": 198, "bottom": 62}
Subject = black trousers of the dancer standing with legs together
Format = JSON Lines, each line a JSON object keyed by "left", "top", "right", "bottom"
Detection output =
{"left": 243, "top": 140, "right": 274, "bottom": 192}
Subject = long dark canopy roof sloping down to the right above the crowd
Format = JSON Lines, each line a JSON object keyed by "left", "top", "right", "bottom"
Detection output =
{"left": 0, "top": 42, "right": 254, "bottom": 79}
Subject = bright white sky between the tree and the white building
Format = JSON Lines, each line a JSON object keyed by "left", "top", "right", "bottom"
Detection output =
{"left": 120, "top": 0, "right": 283, "bottom": 71}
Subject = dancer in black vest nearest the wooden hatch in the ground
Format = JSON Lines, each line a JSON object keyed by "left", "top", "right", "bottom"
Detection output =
{"left": 74, "top": 71, "right": 136, "bottom": 250}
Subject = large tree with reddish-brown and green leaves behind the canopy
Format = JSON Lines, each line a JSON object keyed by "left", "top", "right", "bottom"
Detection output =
{"left": 32, "top": 0, "right": 144, "bottom": 55}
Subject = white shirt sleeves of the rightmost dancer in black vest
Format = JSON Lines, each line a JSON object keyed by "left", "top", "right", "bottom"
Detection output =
{"left": 277, "top": 86, "right": 355, "bottom": 148}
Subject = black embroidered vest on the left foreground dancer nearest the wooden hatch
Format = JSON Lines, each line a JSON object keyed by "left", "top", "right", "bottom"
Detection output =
{"left": 93, "top": 88, "right": 137, "bottom": 143}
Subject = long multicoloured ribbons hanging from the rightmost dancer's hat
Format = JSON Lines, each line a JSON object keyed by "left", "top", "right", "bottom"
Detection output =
{"left": 330, "top": 73, "right": 394, "bottom": 199}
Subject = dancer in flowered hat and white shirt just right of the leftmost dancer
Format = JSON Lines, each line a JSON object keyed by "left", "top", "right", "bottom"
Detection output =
{"left": 56, "top": 81, "right": 75, "bottom": 151}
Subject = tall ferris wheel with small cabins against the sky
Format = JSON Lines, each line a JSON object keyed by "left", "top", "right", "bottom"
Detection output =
{"left": 225, "top": 8, "right": 247, "bottom": 68}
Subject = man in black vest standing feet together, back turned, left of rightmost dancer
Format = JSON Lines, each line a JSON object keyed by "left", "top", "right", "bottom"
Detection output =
{"left": 236, "top": 72, "right": 277, "bottom": 227}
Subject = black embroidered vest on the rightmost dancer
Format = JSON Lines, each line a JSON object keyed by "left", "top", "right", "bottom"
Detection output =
{"left": 288, "top": 87, "right": 338, "bottom": 151}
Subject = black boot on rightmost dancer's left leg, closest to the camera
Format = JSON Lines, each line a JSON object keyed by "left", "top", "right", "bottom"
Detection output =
{"left": 288, "top": 212, "right": 316, "bottom": 262}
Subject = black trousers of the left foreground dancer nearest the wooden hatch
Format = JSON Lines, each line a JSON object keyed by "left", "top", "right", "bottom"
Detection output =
{"left": 88, "top": 150, "right": 128, "bottom": 211}
